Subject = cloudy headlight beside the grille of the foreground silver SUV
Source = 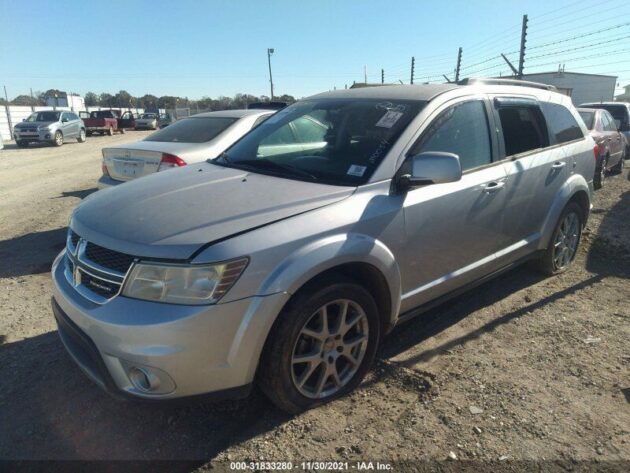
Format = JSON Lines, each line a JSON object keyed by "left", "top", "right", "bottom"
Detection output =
{"left": 122, "top": 258, "right": 248, "bottom": 305}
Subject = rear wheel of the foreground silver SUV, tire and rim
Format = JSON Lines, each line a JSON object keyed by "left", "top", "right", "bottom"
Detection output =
{"left": 535, "top": 202, "right": 584, "bottom": 276}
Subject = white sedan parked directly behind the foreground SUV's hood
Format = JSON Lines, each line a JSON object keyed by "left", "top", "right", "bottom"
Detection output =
{"left": 98, "top": 110, "right": 271, "bottom": 189}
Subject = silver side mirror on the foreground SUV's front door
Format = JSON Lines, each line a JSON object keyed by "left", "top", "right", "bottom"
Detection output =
{"left": 399, "top": 151, "right": 462, "bottom": 190}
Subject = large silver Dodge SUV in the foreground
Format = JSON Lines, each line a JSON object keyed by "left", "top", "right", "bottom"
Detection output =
{"left": 52, "top": 81, "right": 595, "bottom": 412}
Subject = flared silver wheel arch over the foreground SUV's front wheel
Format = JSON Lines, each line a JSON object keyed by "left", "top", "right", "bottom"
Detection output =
{"left": 260, "top": 233, "right": 401, "bottom": 323}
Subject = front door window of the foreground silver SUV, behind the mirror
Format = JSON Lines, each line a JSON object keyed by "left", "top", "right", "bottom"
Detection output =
{"left": 413, "top": 100, "right": 492, "bottom": 171}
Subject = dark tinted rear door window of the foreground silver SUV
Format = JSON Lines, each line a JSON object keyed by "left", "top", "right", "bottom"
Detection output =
{"left": 499, "top": 104, "right": 549, "bottom": 156}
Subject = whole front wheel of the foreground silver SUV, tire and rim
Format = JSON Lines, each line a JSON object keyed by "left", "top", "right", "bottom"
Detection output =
{"left": 258, "top": 277, "right": 380, "bottom": 413}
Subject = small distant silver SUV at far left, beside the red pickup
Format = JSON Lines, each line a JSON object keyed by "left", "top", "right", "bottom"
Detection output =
{"left": 13, "top": 110, "right": 86, "bottom": 148}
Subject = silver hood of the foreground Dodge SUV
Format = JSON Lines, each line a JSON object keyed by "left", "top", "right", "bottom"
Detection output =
{"left": 71, "top": 163, "right": 355, "bottom": 259}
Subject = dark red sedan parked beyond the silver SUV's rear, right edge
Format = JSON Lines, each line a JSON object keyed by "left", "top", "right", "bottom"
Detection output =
{"left": 578, "top": 108, "right": 626, "bottom": 189}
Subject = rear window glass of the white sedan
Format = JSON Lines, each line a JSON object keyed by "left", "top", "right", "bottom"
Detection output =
{"left": 144, "top": 117, "right": 237, "bottom": 143}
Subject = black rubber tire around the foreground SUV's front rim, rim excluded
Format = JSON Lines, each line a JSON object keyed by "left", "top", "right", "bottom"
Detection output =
{"left": 257, "top": 276, "right": 380, "bottom": 414}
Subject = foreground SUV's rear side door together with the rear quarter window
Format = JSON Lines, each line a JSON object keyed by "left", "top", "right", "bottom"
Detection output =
{"left": 494, "top": 96, "right": 584, "bottom": 263}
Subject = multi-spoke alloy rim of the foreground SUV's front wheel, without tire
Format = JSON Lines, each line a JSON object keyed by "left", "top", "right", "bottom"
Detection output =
{"left": 291, "top": 299, "right": 369, "bottom": 399}
